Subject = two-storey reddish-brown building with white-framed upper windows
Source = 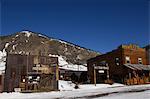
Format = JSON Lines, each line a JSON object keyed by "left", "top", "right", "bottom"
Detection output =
{"left": 87, "top": 44, "right": 150, "bottom": 84}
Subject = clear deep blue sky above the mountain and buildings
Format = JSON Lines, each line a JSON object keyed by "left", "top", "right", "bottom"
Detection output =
{"left": 0, "top": 0, "right": 150, "bottom": 53}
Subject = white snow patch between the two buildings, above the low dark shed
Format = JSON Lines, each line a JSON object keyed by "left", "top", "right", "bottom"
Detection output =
{"left": 49, "top": 54, "right": 87, "bottom": 71}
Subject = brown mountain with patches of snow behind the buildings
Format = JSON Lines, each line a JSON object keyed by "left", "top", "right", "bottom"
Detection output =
{"left": 0, "top": 31, "right": 100, "bottom": 71}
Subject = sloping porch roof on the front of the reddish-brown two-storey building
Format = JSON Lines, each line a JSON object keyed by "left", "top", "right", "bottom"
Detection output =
{"left": 124, "top": 64, "right": 150, "bottom": 71}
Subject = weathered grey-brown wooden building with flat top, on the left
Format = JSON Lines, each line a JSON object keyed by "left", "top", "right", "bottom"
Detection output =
{"left": 4, "top": 54, "right": 58, "bottom": 92}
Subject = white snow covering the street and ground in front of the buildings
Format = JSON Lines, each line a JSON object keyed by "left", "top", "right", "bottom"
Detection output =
{"left": 0, "top": 81, "right": 150, "bottom": 99}
